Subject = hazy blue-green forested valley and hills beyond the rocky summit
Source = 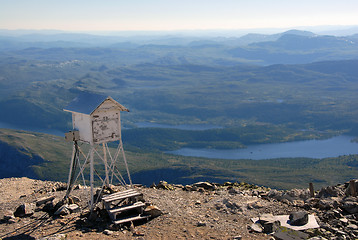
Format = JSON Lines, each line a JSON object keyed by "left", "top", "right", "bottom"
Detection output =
{"left": 0, "top": 30, "right": 358, "bottom": 189}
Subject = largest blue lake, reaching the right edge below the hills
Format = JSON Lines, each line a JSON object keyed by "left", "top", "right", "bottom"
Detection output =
{"left": 167, "top": 135, "right": 358, "bottom": 160}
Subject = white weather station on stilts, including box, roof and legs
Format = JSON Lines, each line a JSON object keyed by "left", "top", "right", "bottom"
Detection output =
{"left": 64, "top": 92, "right": 132, "bottom": 211}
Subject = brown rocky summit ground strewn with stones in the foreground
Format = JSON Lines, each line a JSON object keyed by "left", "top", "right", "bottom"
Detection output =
{"left": 0, "top": 178, "right": 358, "bottom": 239}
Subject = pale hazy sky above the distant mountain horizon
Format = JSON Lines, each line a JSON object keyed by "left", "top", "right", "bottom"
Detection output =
{"left": 0, "top": 0, "right": 358, "bottom": 31}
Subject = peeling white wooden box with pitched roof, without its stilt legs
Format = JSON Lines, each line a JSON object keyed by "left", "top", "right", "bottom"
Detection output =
{"left": 64, "top": 93, "right": 129, "bottom": 145}
